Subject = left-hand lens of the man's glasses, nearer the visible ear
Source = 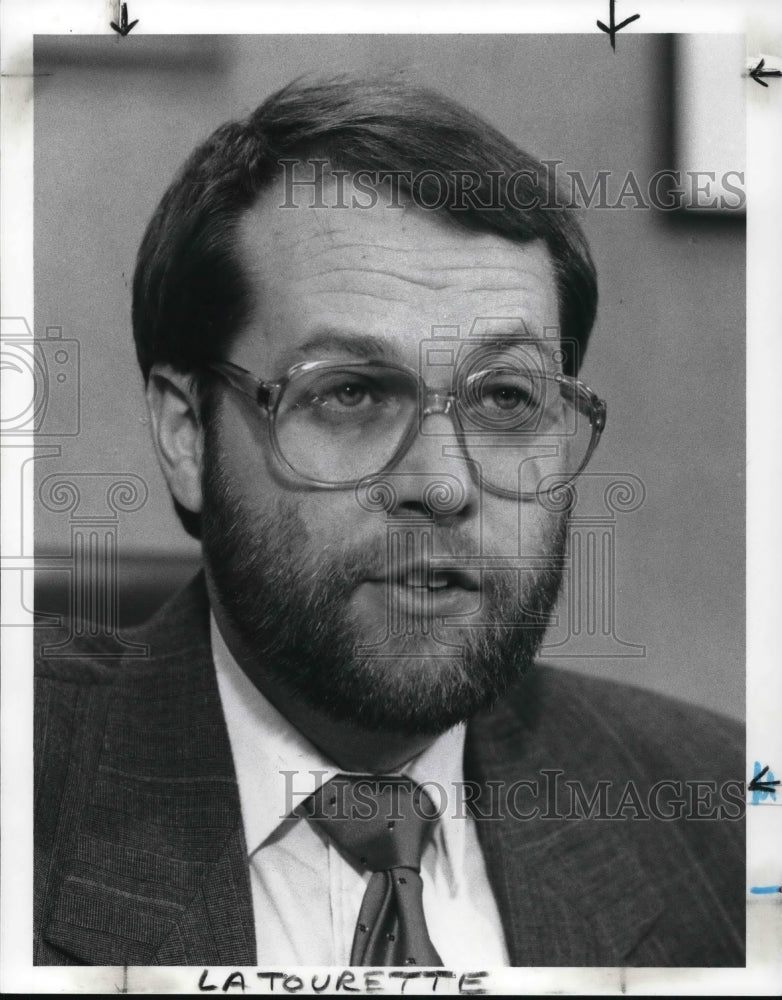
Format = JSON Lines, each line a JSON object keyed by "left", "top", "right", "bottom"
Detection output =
{"left": 275, "top": 365, "right": 418, "bottom": 484}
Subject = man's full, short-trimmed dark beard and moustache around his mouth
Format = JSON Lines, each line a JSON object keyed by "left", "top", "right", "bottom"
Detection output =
{"left": 201, "top": 434, "right": 567, "bottom": 736}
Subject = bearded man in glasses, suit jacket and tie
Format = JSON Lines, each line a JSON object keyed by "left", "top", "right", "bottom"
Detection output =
{"left": 35, "top": 80, "right": 744, "bottom": 967}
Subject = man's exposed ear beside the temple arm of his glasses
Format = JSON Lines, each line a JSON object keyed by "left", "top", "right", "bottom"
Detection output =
{"left": 147, "top": 365, "right": 204, "bottom": 514}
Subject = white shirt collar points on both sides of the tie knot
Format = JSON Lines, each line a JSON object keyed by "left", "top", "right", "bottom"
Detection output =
{"left": 210, "top": 615, "right": 465, "bottom": 877}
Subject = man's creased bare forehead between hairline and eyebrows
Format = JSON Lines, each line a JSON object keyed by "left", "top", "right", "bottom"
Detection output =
{"left": 232, "top": 175, "right": 558, "bottom": 377}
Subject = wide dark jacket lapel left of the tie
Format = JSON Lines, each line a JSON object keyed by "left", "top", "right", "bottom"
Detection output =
{"left": 44, "top": 579, "right": 255, "bottom": 965}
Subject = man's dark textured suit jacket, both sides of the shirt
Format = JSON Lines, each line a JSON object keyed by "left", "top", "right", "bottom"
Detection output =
{"left": 34, "top": 577, "right": 745, "bottom": 967}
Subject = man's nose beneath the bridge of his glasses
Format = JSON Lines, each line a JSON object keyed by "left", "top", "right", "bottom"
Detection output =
{"left": 366, "top": 409, "right": 480, "bottom": 521}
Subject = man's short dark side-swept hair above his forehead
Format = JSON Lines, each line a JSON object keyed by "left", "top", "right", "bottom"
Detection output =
{"left": 133, "top": 77, "right": 597, "bottom": 537}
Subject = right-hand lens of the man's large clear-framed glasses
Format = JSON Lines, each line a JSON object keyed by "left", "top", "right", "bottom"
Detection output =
{"left": 459, "top": 362, "right": 592, "bottom": 493}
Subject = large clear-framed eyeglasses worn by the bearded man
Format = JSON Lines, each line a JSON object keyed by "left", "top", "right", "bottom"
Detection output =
{"left": 205, "top": 351, "right": 606, "bottom": 499}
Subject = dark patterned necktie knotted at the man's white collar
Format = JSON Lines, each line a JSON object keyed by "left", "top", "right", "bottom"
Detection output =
{"left": 305, "top": 774, "right": 442, "bottom": 966}
